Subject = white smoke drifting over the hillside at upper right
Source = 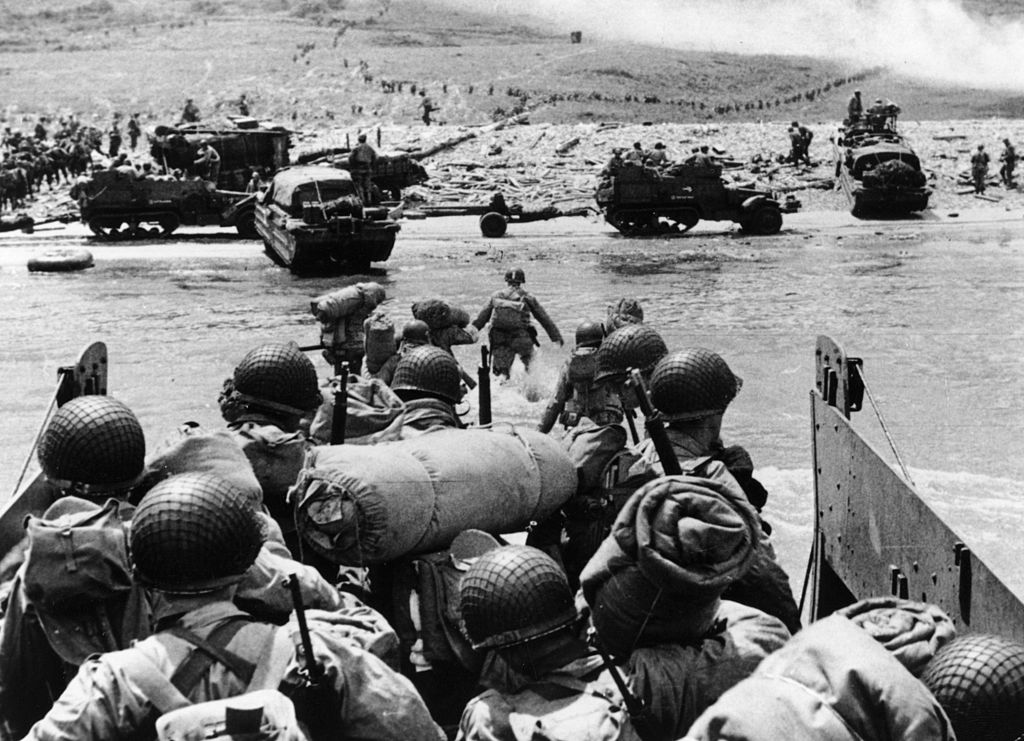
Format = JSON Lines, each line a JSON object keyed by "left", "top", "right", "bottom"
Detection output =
{"left": 439, "top": 0, "right": 1024, "bottom": 92}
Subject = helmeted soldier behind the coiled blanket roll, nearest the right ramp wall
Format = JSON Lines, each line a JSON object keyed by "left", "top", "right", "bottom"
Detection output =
{"left": 630, "top": 348, "right": 800, "bottom": 633}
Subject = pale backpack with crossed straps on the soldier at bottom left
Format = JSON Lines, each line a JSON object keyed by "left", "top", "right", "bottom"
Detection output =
{"left": 120, "top": 619, "right": 307, "bottom": 741}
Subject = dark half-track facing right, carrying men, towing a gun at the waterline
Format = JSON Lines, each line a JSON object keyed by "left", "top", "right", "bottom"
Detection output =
{"left": 596, "top": 165, "right": 796, "bottom": 236}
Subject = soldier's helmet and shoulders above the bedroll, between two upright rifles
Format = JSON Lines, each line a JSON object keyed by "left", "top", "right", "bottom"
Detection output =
{"left": 391, "top": 345, "right": 464, "bottom": 438}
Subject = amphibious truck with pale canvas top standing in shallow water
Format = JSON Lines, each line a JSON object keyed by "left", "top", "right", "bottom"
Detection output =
{"left": 256, "top": 165, "right": 400, "bottom": 272}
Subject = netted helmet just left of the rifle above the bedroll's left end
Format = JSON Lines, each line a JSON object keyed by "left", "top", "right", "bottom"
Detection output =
{"left": 233, "top": 342, "right": 324, "bottom": 417}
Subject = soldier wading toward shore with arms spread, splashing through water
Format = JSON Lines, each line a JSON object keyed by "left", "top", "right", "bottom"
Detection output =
{"left": 473, "top": 267, "right": 565, "bottom": 381}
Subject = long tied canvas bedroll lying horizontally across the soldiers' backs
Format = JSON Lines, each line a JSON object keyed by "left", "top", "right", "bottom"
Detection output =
{"left": 291, "top": 428, "right": 577, "bottom": 566}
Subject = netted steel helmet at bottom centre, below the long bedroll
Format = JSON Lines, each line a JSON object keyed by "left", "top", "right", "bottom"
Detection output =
{"left": 459, "top": 546, "right": 577, "bottom": 649}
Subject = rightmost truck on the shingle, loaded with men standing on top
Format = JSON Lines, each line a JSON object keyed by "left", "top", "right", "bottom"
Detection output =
{"left": 833, "top": 104, "right": 932, "bottom": 216}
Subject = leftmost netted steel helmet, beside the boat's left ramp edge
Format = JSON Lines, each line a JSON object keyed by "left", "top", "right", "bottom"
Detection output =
{"left": 39, "top": 396, "right": 145, "bottom": 495}
